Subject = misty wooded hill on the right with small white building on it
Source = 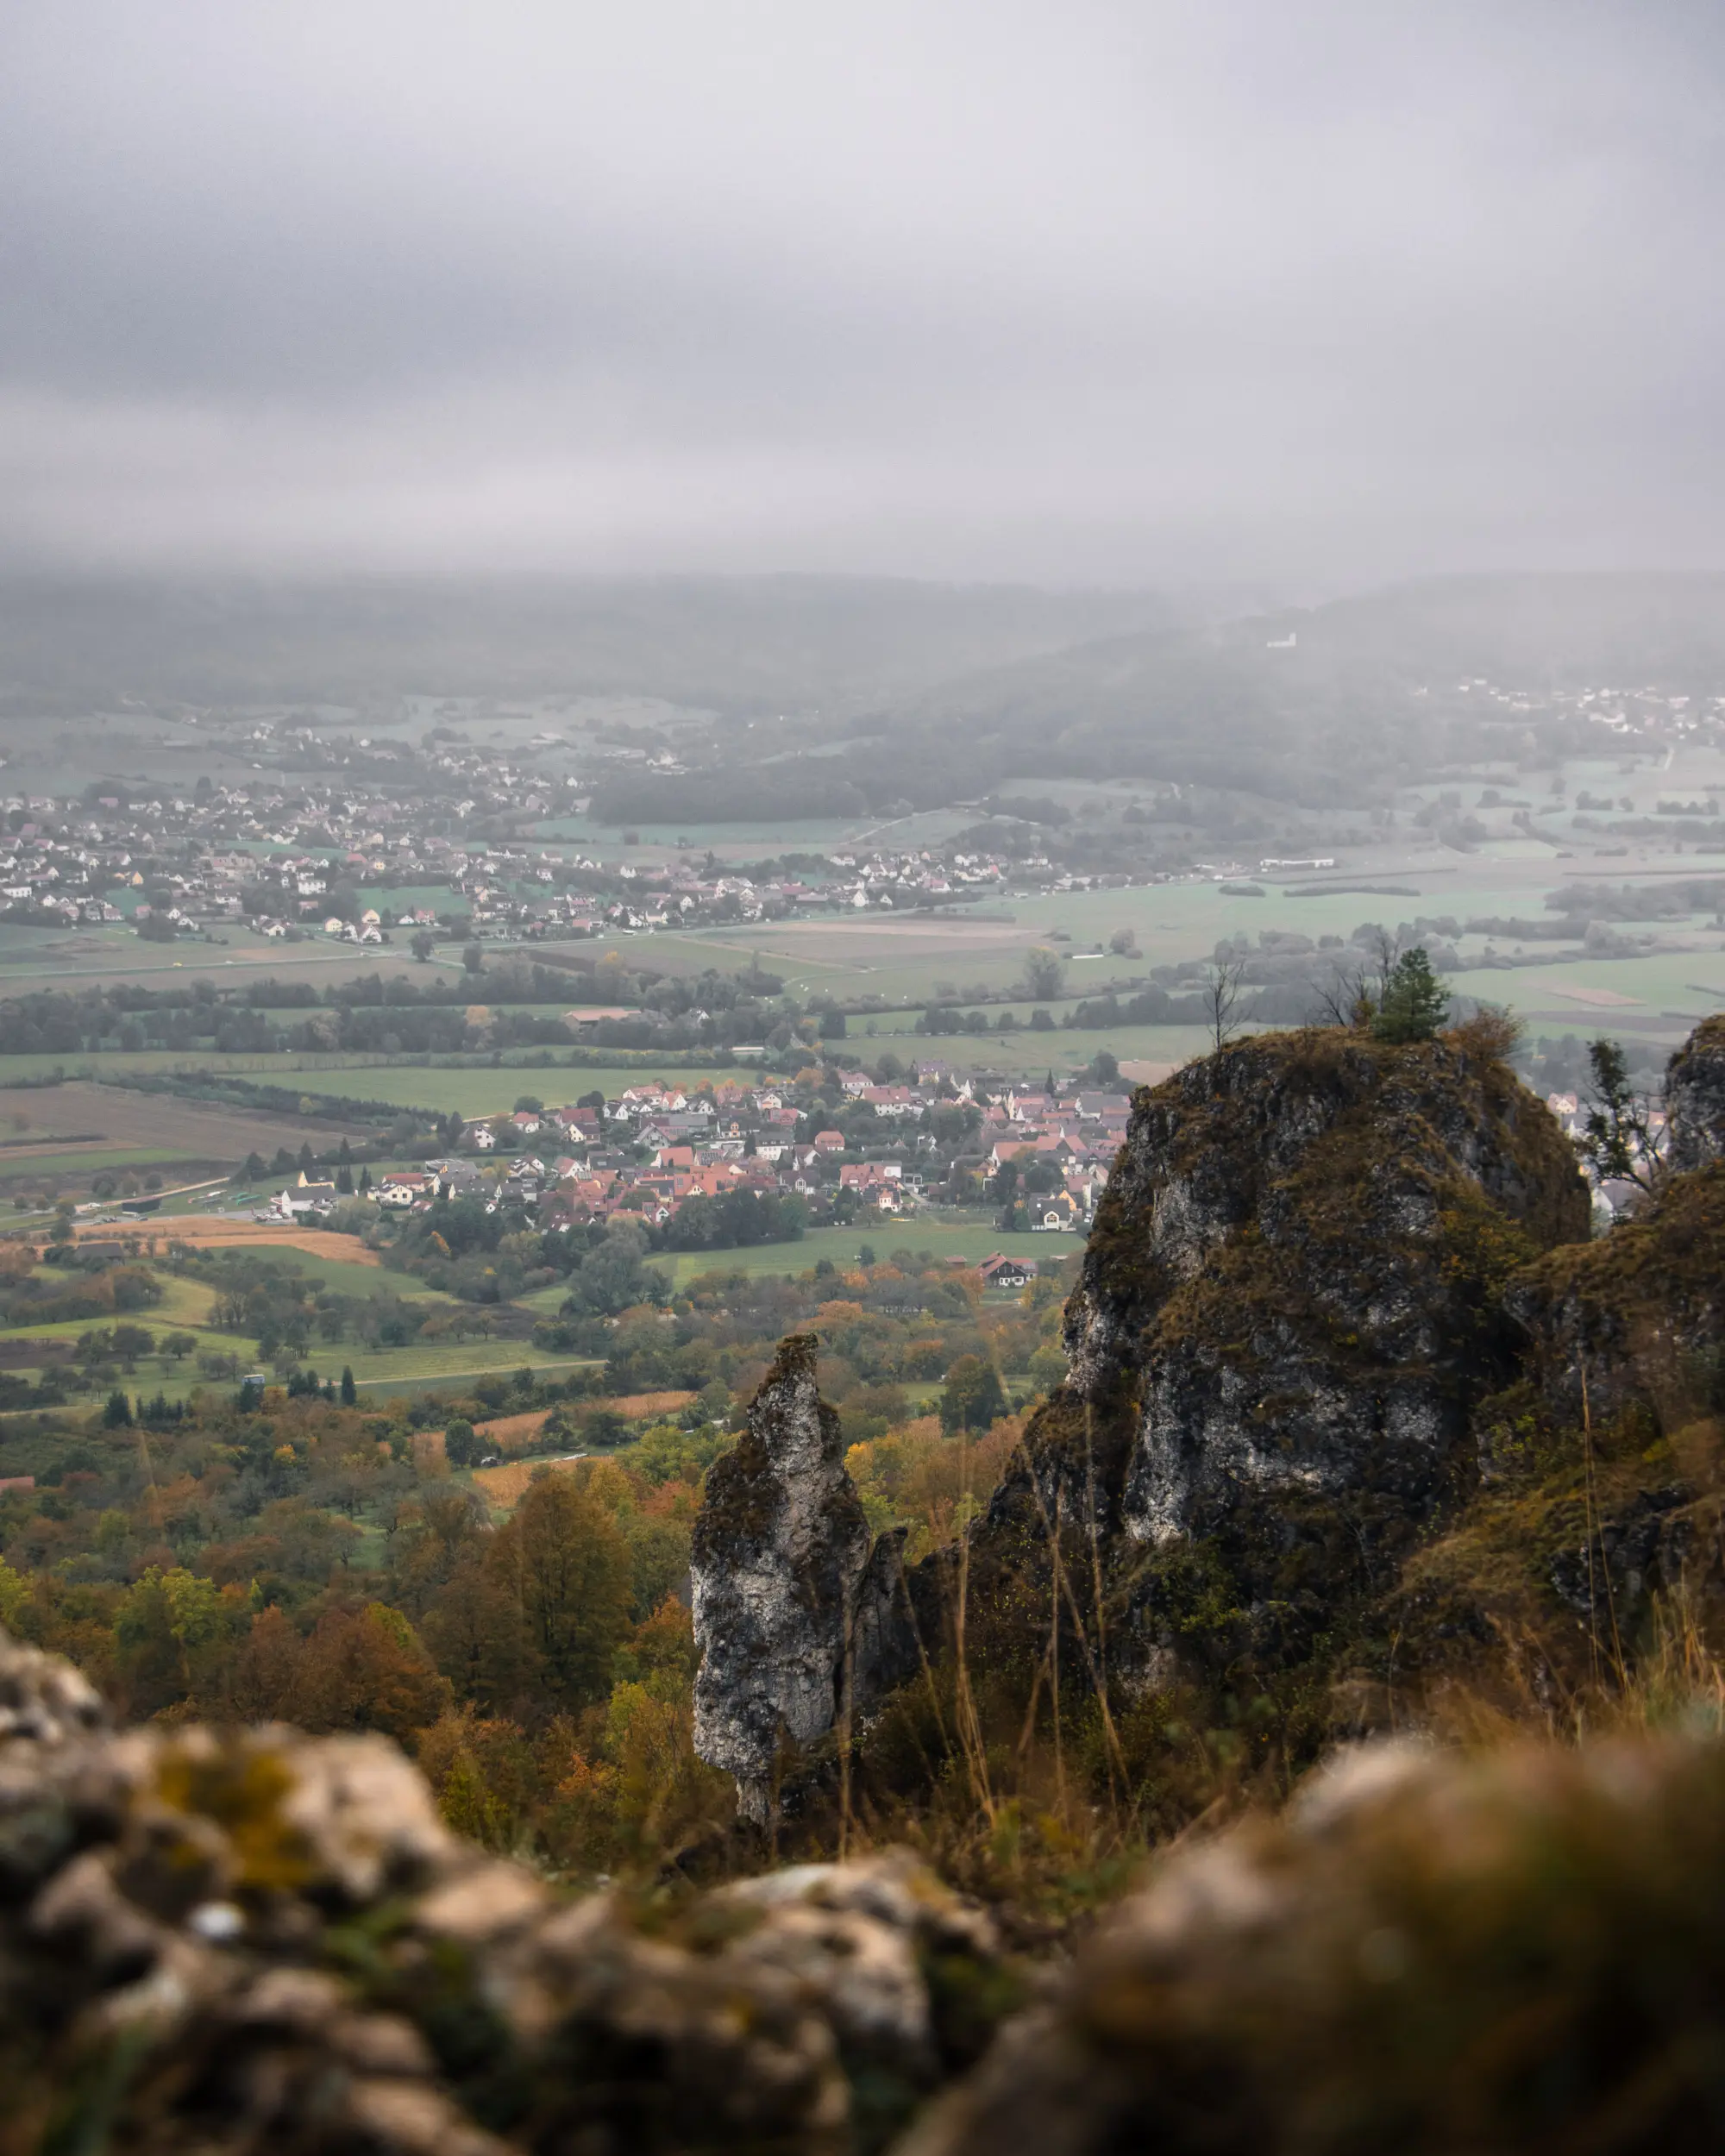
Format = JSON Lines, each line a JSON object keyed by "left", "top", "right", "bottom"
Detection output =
{"left": 602, "top": 573, "right": 1725, "bottom": 819}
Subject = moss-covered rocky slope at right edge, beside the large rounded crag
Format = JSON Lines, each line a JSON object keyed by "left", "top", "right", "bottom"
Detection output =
{"left": 1358, "top": 1147, "right": 1725, "bottom": 1719}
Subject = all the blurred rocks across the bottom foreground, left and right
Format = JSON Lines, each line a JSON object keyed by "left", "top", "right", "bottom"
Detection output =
{"left": 0, "top": 1634, "right": 1725, "bottom": 2156}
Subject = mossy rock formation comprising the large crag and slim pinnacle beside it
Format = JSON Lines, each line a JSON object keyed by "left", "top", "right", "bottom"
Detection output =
{"left": 694, "top": 1029, "right": 1604, "bottom": 1768}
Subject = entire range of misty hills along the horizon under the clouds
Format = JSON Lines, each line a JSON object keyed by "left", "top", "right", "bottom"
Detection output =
{"left": 0, "top": 572, "right": 1725, "bottom": 822}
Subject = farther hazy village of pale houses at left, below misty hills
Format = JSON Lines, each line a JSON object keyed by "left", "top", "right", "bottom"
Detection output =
{"left": 0, "top": 714, "right": 1397, "bottom": 944}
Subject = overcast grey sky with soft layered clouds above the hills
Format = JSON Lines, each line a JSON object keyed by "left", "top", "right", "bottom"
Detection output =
{"left": 0, "top": 0, "right": 1725, "bottom": 591}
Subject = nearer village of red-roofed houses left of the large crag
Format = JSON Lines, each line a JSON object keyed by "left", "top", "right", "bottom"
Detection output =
{"left": 270, "top": 1068, "right": 1128, "bottom": 1233}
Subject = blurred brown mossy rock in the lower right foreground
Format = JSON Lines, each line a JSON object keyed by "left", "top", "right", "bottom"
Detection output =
{"left": 901, "top": 1742, "right": 1725, "bottom": 2156}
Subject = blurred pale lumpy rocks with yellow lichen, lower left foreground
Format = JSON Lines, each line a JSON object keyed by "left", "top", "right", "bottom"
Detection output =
{"left": 0, "top": 1634, "right": 1016, "bottom": 2156}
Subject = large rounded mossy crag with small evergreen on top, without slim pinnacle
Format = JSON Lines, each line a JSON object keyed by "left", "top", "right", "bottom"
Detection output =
{"left": 973, "top": 1029, "right": 1590, "bottom": 1677}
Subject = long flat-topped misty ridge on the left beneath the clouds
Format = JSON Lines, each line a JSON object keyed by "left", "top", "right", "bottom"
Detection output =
{"left": 0, "top": 576, "right": 1173, "bottom": 711}
